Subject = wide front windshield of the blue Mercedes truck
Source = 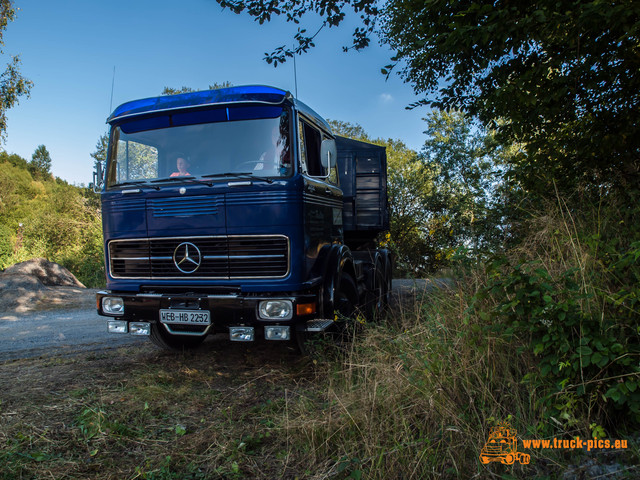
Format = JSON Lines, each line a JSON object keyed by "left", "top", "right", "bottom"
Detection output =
{"left": 107, "top": 106, "right": 292, "bottom": 187}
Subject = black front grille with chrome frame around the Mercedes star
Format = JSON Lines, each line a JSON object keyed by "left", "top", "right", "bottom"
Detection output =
{"left": 109, "top": 235, "right": 289, "bottom": 279}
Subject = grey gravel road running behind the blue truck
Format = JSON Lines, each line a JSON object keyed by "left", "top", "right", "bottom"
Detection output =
{"left": 0, "top": 280, "right": 437, "bottom": 361}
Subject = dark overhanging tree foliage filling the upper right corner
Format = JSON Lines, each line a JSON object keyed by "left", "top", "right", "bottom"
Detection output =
{"left": 383, "top": 0, "right": 640, "bottom": 195}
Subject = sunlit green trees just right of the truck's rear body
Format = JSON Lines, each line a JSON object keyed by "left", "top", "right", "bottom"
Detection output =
{"left": 329, "top": 116, "right": 508, "bottom": 275}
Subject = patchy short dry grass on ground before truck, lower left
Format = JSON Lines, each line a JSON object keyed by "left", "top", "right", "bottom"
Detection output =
{"left": 0, "top": 342, "right": 309, "bottom": 479}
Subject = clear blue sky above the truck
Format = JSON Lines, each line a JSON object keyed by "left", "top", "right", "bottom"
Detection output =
{"left": 0, "top": 0, "right": 426, "bottom": 184}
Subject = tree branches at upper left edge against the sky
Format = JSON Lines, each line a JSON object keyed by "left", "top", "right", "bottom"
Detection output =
{"left": 0, "top": 0, "right": 33, "bottom": 140}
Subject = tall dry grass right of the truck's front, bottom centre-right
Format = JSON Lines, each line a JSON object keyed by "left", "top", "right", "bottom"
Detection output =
{"left": 284, "top": 284, "right": 552, "bottom": 479}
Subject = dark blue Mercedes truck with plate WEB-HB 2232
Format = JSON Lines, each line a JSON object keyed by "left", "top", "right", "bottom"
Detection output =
{"left": 94, "top": 86, "right": 392, "bottom": 349}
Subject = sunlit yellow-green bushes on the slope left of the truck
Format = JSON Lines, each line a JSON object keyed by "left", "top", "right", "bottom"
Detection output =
{"left": 0, "top": 152, "right": 104, "bottom": 286}
